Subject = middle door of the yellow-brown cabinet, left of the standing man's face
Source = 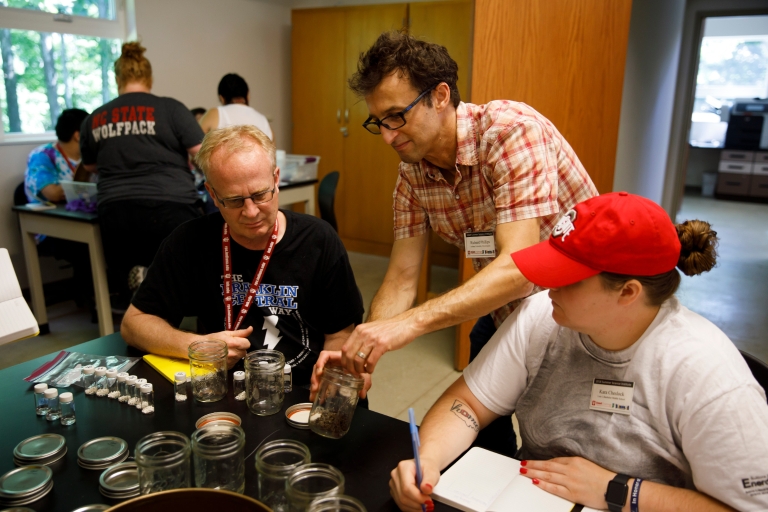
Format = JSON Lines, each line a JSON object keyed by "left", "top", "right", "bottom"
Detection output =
{"left": 339, "top": 4, "right": 408, "bottom": 256}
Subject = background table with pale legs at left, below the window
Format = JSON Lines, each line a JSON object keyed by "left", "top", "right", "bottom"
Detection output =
{"left": 13, "top": 206, "right": 115, "bottom": 336}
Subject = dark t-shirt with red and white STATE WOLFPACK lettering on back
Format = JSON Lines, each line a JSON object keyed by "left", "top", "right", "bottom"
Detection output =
{"left": 80, "top": 92, "right": 204, "bottom": 204}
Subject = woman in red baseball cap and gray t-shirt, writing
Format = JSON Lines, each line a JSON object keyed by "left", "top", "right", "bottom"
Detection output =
{"left": 390, "top": 192, "right": 768, "bottom": 512}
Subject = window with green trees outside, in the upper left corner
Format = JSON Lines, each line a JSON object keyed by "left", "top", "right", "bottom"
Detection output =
{"left": 0, "top": 0, "right": 130, "bottom": 140}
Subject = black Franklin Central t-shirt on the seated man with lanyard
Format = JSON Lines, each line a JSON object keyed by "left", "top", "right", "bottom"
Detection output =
{"left": 133, "top": 211, "right": 363, "bottom": 385}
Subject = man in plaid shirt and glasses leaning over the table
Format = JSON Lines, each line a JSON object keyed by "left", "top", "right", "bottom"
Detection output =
{"left": 330, "top": 32, "right": 597, "bottom": 404}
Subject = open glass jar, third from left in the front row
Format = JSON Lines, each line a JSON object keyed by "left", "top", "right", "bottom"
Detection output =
{"left": 256, "top": 439, "right": 311, "bottom": 512}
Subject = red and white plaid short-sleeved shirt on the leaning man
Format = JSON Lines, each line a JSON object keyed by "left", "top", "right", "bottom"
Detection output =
{"left": 393, "top": 101, "right": 597, "bottom": 326}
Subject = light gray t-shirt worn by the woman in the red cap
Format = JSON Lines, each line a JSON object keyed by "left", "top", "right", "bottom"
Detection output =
{"left": 464, "top": 292, "right": 768, "bottom": 510}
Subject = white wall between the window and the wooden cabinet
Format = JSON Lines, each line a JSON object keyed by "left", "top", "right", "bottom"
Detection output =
{"left": 136, "top": 0, "right": 291, "bottom": 150}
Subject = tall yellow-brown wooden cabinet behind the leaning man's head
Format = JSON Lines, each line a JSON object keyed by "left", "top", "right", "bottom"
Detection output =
{"left": 292, "top": 0, "right": 473, "bottom": 260}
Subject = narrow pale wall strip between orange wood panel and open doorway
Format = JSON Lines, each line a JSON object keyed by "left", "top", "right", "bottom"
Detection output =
{"left": 613, "top": 0, "right": 685, "bottom": 203}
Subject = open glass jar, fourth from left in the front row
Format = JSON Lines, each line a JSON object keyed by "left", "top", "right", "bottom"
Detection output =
{"left": 285, "top": 463, "right": 344, "bottom": 512}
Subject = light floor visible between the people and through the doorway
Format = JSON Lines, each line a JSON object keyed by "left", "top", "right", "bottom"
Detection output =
{"left": 0, "top": 192, "right": 768, "bottom": 422}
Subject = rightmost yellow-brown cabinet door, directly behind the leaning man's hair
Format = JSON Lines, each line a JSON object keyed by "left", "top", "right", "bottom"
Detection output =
{"left": 408, "top": 0, "right": 474, "bottom": 268}
